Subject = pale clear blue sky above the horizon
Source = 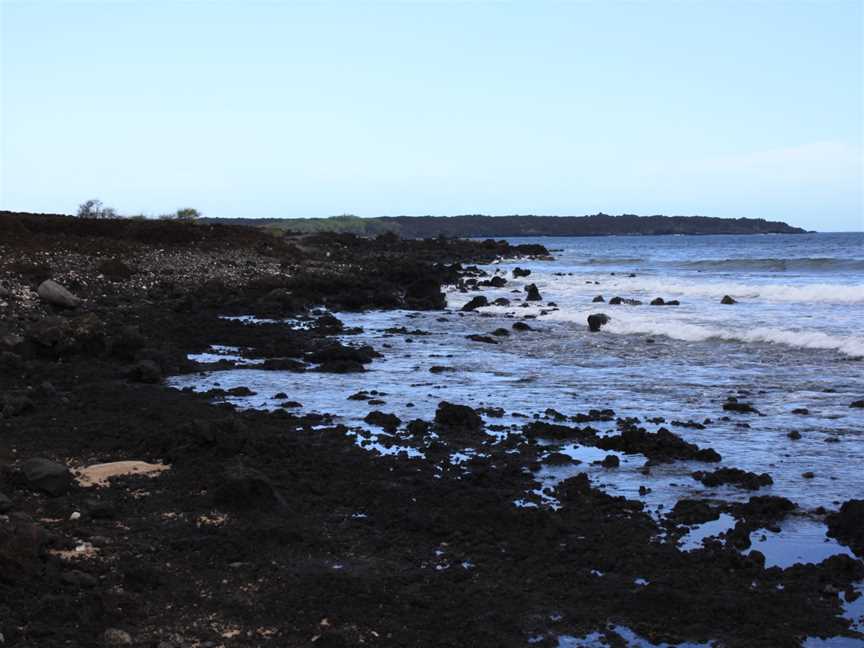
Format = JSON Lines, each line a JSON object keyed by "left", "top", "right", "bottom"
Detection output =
{"left": 0, "top": 0, "right": 864, "bottom": 230}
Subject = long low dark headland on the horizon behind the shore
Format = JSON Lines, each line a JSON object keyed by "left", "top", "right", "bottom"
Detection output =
{"left": 205, "top": 213, "right": 805, "bottom": 238}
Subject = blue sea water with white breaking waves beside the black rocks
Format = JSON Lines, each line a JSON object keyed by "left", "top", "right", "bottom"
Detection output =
{"left": 173, "top": 233, "right": 864, "bottom": 645}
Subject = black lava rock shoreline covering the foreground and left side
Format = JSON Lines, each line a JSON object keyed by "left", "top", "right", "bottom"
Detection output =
{"left": 0, "top": 214, "right": 864, "bottom": 648}
